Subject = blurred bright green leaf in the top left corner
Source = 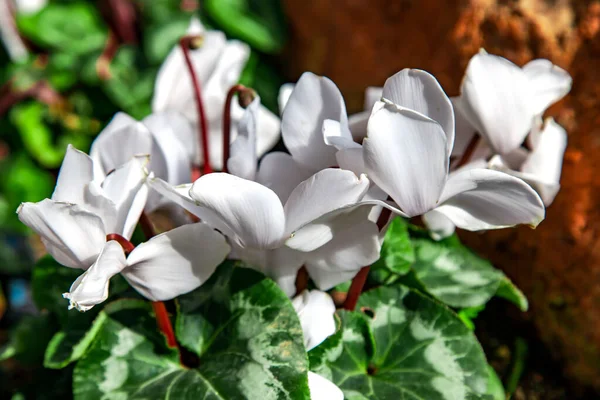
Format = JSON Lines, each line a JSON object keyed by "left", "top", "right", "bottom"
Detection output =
{"left": 17, "top": 1, "right": 107, "bottom": 54}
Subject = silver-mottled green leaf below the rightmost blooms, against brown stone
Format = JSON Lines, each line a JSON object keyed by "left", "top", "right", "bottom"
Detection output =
{"left": 412, "top": 239, "right": 519, "bottom": 308}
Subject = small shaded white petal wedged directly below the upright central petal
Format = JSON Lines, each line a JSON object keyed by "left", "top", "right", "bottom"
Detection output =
{"left": 256, "top": 151, "right": 313, "bottom": 204}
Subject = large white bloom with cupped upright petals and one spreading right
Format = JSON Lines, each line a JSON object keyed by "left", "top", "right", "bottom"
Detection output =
{"left": 363, "top": 69, "right": 544, "bottom": 230}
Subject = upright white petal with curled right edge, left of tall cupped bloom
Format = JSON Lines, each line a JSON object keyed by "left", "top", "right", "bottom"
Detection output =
{"left": 281, "top": 72, "right": 351, "bottom": 171}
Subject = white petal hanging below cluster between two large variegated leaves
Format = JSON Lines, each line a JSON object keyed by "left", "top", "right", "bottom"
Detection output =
{"left": 292, "top": 290, "right": 336, "bottom": 351}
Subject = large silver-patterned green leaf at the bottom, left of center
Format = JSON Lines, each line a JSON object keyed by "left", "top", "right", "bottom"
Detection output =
{"left": 73, "top": 263, "right": 309, "bottom": 400}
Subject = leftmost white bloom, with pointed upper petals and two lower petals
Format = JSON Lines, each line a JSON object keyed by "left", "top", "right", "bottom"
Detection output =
{"left": 17, "top": 146, "right": 229, "bottom": 311}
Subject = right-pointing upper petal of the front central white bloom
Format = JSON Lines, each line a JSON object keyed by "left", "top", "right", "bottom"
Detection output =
{"left": 284, "top": 168, "right": 369, "bottom": 234}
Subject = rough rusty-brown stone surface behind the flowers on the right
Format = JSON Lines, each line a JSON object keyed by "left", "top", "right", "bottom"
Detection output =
{"left": 285, "top": 0, "right": 600, "bottom": 391}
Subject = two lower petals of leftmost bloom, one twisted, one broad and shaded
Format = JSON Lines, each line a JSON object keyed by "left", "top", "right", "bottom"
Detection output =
{"left": 63, "top": 222, "right": 230, "bottom": 311}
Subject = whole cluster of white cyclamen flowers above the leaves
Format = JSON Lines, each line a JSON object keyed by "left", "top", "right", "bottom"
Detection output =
{"left": 18, "top": 20, "right": 571, "bottom": 398}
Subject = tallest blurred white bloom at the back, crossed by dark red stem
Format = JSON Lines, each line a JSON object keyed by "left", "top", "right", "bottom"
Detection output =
{"left": 152, "top": 18, "right": 280, "bottom": 169}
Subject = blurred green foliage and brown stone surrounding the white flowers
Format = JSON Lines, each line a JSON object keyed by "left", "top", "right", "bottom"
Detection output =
{"left": 0, "top": 0, "right": 600, "bottom": 400}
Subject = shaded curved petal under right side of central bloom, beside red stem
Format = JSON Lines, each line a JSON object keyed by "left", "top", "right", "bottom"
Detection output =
{"left": 306, "top": 207, "right": 381, "bottom": 290}
